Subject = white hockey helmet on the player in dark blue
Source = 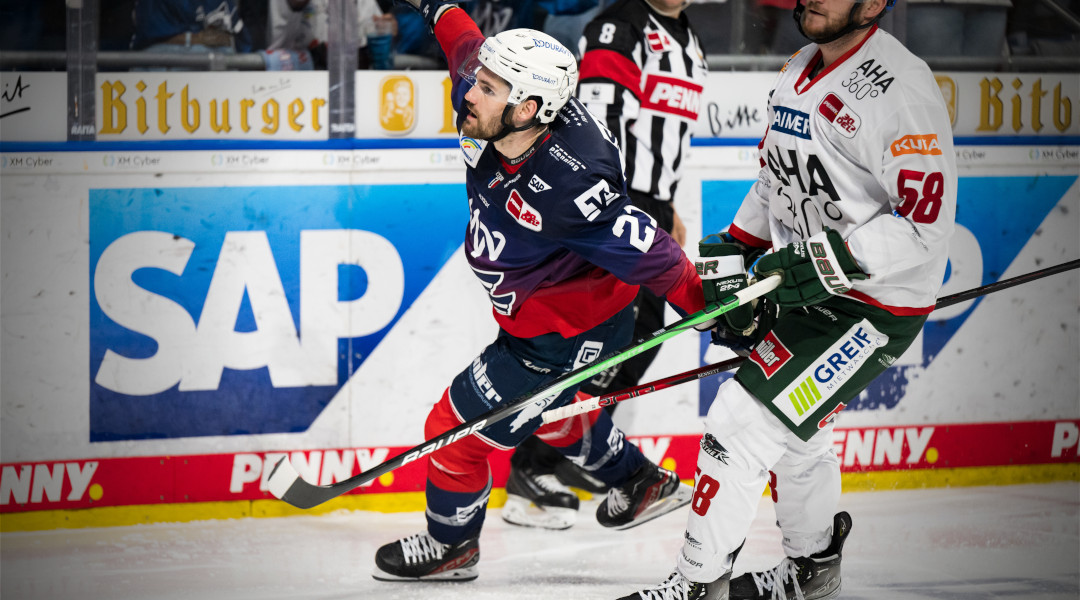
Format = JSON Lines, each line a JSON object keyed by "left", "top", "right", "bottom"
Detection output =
{"left": 458, "top": 29, "right": 578, "bottom": 123}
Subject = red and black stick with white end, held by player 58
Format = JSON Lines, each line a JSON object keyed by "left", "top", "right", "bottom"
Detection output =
{"left": 541, "top": 260, "right": 1080, "bottom": 424}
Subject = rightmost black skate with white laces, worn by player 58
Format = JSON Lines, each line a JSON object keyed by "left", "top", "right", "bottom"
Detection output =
{"left": 731, "top": 513, "right": 851, "bottom": 600}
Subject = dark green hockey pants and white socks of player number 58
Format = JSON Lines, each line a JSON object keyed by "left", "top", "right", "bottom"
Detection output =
{"left": 677, "top": 299, "right": 926, "bottom": 582}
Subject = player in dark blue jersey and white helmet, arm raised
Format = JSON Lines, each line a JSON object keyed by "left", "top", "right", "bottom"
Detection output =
{"left": 373, "top": 0, "right": 704, "bottom": 581}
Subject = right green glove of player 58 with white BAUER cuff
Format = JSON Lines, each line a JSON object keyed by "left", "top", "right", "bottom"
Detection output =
{"left": 751, "top": 228, "right": 869, "bottom": 306}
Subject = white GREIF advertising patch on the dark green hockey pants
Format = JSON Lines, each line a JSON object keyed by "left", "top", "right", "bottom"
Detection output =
{"left": 762, "top": 318, "right": 889, "bottom": 425}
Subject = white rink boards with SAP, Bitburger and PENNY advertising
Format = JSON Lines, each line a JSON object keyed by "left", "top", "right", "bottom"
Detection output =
{"left": 0, "top": 67, "right": 1080, "bottom": 529}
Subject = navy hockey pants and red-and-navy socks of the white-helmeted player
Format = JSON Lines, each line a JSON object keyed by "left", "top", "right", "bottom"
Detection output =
{"left": 424, "top": 306, "right": 646, "bottom": 544}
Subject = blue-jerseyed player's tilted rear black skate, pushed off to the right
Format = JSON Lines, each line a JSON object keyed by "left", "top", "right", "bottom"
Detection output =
{"left": 596, "top": 463, "right": 693, "bottom": 529}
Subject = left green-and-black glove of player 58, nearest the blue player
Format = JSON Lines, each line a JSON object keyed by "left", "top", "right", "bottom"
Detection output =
{"left": 694, "top": 233, "right": 761, "bottom": 352}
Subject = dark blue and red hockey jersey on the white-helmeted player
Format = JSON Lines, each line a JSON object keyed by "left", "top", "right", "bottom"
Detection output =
{"left": 435, "top": 10, "right": 704, "bottom": 338}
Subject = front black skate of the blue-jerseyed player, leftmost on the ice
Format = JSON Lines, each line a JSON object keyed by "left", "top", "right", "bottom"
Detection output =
{"left": 372, "top": 531, "right": 480, "bottom": 582}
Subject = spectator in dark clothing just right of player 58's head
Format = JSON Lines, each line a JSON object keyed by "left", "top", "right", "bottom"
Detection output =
{"left": 906, "top": 0, "right": 1012, "bottom": 58}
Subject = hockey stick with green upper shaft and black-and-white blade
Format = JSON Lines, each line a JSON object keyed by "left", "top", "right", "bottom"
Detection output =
{"left": 268, "top": 275, "right": 780, "bottom": 508}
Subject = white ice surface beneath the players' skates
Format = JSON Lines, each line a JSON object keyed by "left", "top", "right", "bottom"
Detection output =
{"left": 0, "top": 482, "right": 1080, "bottom": 600}
